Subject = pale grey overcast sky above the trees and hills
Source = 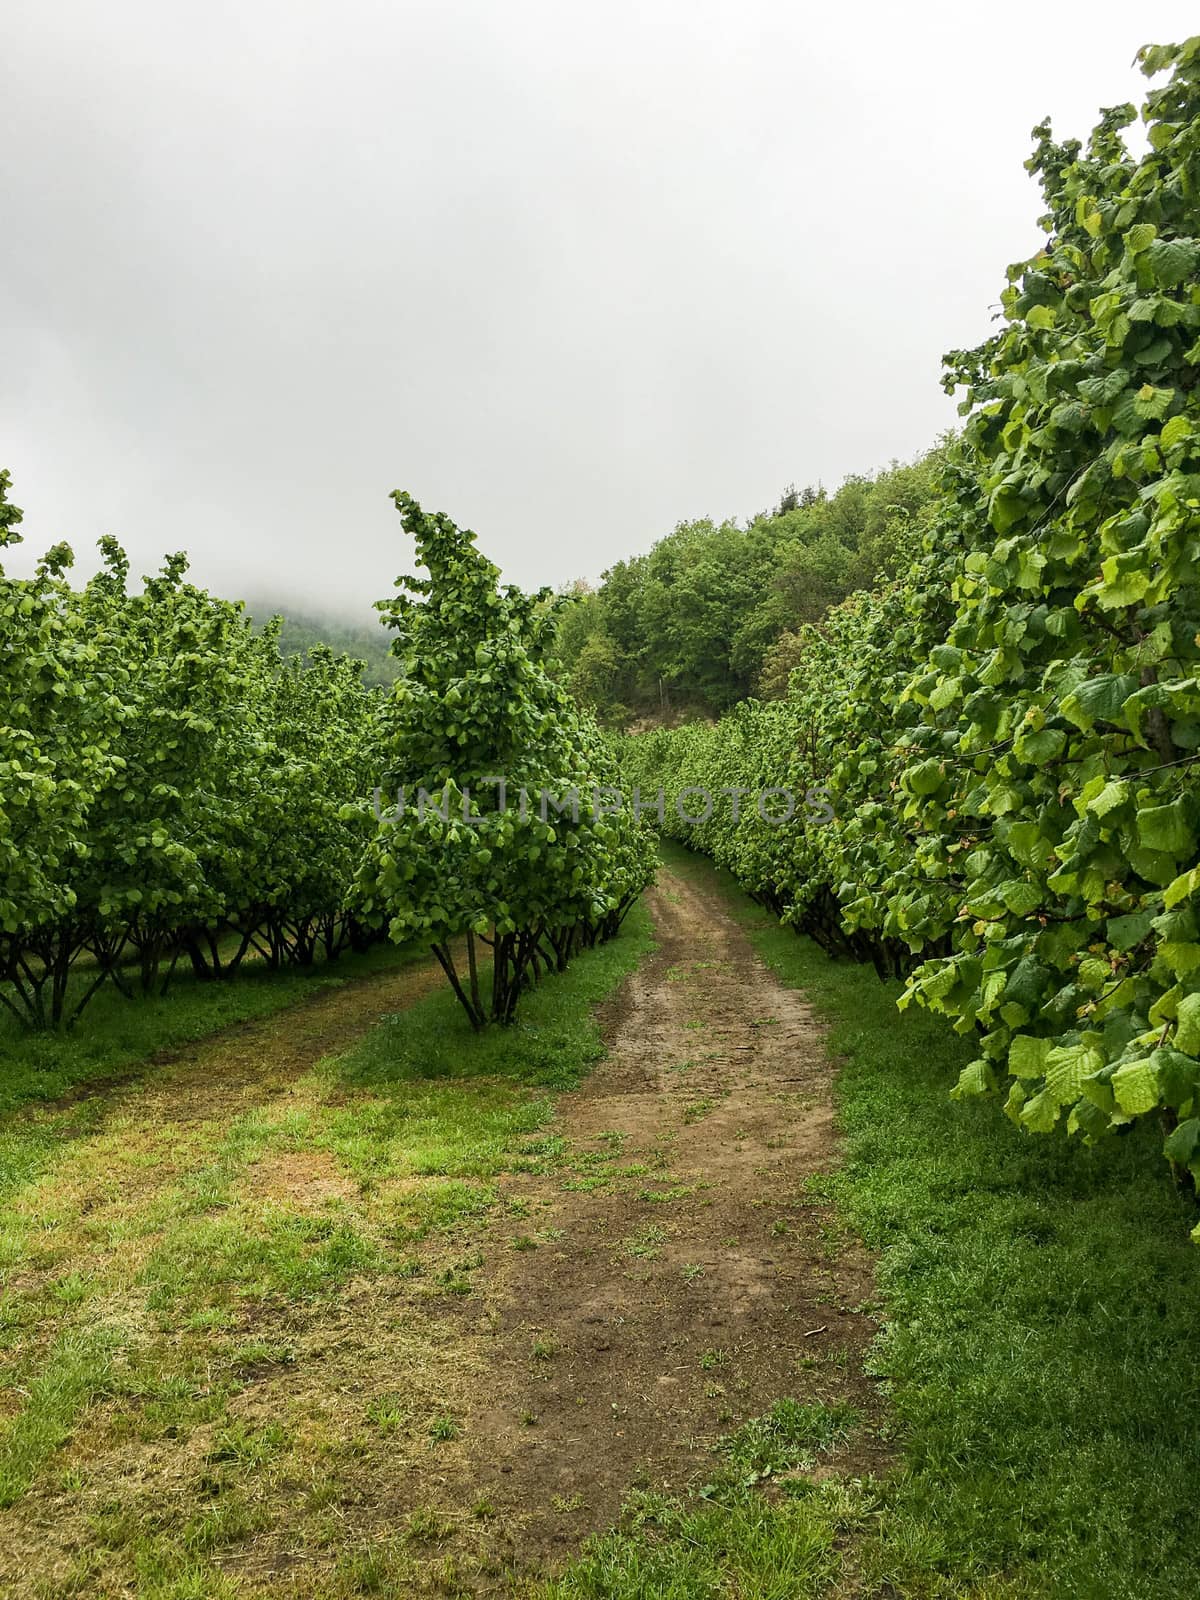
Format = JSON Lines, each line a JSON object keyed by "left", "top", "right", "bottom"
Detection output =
{"left": 0, "top": 0, "right": 1195, "bottom": 613}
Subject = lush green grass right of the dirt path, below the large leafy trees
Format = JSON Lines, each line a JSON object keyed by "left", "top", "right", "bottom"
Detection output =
{"left": 552, "top": 851, "right": 1200, "bottom": 1600}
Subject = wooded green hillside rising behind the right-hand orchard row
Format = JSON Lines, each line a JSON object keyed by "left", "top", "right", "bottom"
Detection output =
{"left": 558, "top": 448, "right": 941, "bottom": 728}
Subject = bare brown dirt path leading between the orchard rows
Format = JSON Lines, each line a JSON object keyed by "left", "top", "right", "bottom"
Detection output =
{"left": 432, "top": 870, "right": 880, "bottom": 1566}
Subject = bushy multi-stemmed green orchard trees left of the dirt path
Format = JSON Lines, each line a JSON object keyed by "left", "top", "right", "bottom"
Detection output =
{"left": 0, "top": 472, "right": 653, "bottom": 1027}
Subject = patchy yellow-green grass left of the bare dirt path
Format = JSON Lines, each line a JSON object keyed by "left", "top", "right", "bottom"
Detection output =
{"left": 0, "top": 907, "right": 653, "bottom": 1600}
